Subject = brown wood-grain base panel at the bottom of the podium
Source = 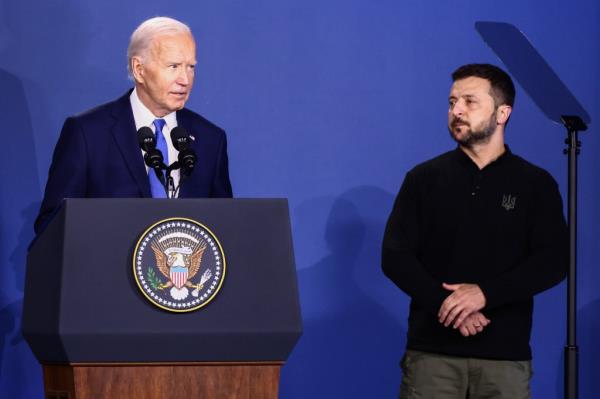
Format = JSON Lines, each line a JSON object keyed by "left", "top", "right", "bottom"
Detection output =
{"left": 43, "top": 363, "right": 281, "bottom": 399}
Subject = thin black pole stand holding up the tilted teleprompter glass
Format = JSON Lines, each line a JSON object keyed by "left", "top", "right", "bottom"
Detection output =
{"left": 561, "top": 115, "right": 587, "bottom": 399}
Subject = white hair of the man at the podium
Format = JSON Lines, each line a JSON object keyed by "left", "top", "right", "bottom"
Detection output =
{"left": 127, "top": 17, "right": 192, "bottom": 78}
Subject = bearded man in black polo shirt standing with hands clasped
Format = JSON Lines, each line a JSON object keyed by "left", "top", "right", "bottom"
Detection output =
{"left": 382, "top": 64, "right": 568, "bottom": 399}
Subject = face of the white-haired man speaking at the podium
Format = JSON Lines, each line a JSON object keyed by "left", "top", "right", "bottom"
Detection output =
{"left": 132, "top": 33, "right": 196, "bottom": 117}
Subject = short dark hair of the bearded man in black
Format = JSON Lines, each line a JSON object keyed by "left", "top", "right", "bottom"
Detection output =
{"left": 452, "top": 64, "right": 515, "bottom": 107}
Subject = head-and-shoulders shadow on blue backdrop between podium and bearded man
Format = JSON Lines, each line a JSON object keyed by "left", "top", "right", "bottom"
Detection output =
{"left": 281, "top": 187, "right": 406, "bottom": 398}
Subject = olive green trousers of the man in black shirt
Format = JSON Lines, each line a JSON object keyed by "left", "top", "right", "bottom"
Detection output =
{"left": 400, "top": 350, "right": 532, "bottom": 399}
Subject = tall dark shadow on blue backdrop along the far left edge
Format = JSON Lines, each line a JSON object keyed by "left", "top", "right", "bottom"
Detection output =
{"left": 0, "top": 69, "right": 42, "bottom": 399}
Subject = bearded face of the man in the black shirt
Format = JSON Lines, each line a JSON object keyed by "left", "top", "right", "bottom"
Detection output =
{"left": 448, "top": 77, "right": 498, "bottom": 147}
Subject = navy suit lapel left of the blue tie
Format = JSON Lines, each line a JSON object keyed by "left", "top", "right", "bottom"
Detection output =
{"left": 111, "top": 90, "right": 152, "bottom": 198}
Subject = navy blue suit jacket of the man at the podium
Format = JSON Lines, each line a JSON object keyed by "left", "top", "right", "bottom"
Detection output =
{"left": 34, "top": 91, "right": 232, "bottom": 234}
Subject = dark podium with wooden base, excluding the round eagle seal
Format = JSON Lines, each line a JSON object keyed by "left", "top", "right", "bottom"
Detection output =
{"left": 23, "top": 199, "right": 302, "bottom": 399}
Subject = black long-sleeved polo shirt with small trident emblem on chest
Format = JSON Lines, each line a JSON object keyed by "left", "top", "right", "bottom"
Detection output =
{"left": 382, "top": 147, "right": 568, "bottom": 360}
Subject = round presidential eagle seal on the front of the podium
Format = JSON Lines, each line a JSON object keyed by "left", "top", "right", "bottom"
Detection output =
{"left": 133, "top": 218, "right": 225, "bottom": 312}
